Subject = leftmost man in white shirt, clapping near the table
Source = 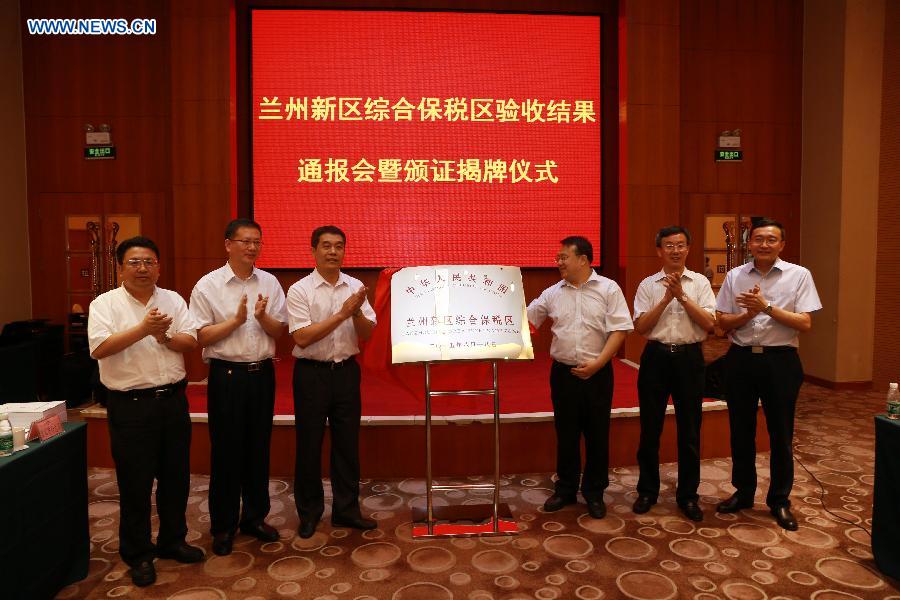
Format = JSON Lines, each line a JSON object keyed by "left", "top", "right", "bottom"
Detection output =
{"left": 88, "top": 237, "right": 203, "bottom": 587}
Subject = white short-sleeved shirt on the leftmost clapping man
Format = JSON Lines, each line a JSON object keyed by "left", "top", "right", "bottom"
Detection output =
{"left": 88, "top": 286, "right": 197, "bottom": 392}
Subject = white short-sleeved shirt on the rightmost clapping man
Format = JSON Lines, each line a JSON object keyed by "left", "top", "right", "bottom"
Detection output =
{"left": 716, "top": 258, "right": 822, "bottom": 347}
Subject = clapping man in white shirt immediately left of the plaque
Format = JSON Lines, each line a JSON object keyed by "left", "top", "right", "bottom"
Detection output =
{"left": 287, "top": 225, "right": 376, "bottom": 538}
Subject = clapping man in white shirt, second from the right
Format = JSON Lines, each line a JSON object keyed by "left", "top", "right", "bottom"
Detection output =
{"left": 632, "top": 225, "right": 716, "bottom": 521}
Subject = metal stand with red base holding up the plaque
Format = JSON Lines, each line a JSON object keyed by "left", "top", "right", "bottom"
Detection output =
{"left": 412, "top": 360, "right": 519, "bottom": 538}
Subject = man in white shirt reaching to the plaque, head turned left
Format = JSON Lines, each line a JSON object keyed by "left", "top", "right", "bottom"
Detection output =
{"left": 528, "top": 236, "right": 633, "bottom": 519}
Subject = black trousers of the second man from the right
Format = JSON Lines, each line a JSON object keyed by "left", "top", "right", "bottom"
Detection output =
{"left": 637, "top": 342, "right": 705, "bottom": 502}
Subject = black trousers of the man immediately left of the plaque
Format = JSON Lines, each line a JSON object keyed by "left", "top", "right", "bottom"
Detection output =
{"left": 294, "top": 358, "right": 362, "bottom": 521}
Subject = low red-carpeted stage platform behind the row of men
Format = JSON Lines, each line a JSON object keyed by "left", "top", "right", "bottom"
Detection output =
{"left": 82, "top": 355, "right": 769, "bottom": 478}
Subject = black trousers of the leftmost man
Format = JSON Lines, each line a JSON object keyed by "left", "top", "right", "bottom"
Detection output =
{"left": 106, "top": 382, "right": 191, "bottom": 566}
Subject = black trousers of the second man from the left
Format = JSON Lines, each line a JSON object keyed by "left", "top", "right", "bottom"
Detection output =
{"left": 207, "top": 359, "right": 275, "bottom": 535}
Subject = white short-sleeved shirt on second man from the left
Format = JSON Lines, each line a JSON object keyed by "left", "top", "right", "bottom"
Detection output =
{"left": 191, "top": 263, "right": 287, "bottom": 362}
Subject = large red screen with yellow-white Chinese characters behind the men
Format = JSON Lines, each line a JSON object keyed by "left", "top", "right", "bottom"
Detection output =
{"left": 251, "top": 10, "right": 601, "bottom": 268}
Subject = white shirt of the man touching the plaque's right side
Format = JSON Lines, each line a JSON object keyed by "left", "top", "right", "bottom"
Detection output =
{"left": 528, "top": 269, "right": 634, "bottom": 366}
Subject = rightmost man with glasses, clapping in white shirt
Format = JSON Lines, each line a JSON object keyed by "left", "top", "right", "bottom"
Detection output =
{"left": 716, "top": 218, "right": 822, "bottom": 531}
